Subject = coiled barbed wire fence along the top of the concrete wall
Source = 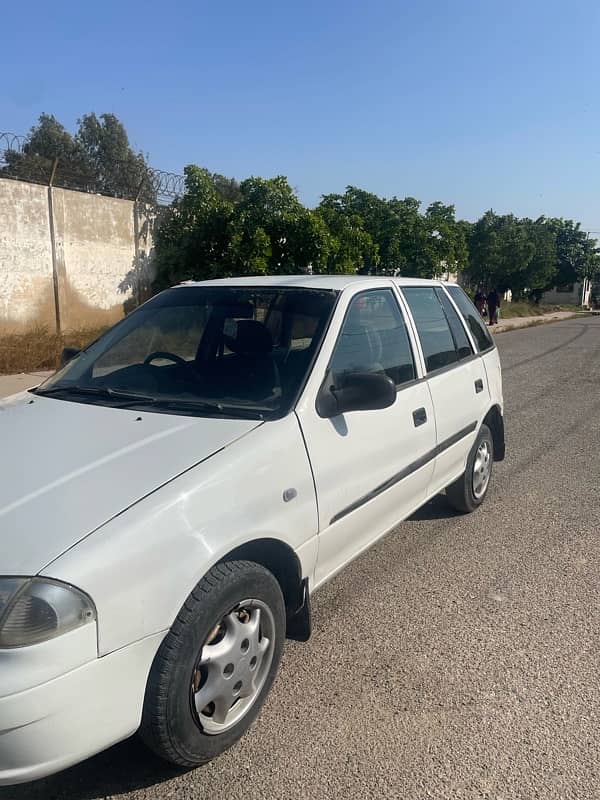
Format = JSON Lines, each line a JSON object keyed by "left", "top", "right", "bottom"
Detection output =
{"left": 0, "top": 132, "right": 185, "bottom": 206}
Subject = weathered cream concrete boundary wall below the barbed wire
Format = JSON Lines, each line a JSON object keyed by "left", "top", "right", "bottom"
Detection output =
{"left": 0, "top": 179, "right": 157, "bottom": 333}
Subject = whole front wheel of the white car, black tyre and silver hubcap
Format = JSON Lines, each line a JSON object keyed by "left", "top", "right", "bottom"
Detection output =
{"left": 140, "top": 561, "right": 285, "bottom": 767}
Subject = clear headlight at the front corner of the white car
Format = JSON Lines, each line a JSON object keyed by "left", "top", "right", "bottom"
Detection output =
{"left": 0, "top": 578, "right": 96, "bottom": 648}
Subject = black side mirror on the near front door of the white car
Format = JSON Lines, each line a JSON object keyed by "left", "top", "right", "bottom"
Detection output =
{"left": 317, "top": 372, "right": 396, "bottom": 419}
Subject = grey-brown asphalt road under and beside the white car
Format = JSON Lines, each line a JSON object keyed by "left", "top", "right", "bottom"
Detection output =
{"left": 0, "top": 317, "right": 600, "bottom": 800}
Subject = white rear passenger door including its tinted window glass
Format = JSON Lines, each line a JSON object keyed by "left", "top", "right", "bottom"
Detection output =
{"left": 402, "top": 285, "right": 489, "bottom": 494}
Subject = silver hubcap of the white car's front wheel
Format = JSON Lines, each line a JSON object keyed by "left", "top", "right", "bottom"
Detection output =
{"left": 192, "top": 600, "right": 275, "bottom": 735}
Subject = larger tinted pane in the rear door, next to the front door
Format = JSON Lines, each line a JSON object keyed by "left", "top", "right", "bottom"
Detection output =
{"left": 402, "top": 286, "right": 459, "bottom": 372}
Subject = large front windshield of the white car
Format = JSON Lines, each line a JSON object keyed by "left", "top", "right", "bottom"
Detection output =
{"left": 36, "top": 286, "right": 336, "bottom": 419}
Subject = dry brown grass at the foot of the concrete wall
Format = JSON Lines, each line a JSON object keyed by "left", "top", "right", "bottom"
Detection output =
{"left": 0, "top": 328, "right": 106, "bottom": 375}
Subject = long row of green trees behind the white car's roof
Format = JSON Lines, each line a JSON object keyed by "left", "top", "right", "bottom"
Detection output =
{"left": 156, "top": 166, "right": 600, "bottom": 299}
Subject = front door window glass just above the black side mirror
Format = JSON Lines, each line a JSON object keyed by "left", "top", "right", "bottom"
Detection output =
{"left": 330, "top": 289, "right": 417, "bottom": 386}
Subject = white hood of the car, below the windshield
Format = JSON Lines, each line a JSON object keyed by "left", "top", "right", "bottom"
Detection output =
{"left": 0, "top": 392, "right": 261, "bottom": 575}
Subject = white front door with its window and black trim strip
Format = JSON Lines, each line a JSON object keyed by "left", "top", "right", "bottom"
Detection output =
{"left": 297, "top": 285, "right": 435, "bottom": 585}
